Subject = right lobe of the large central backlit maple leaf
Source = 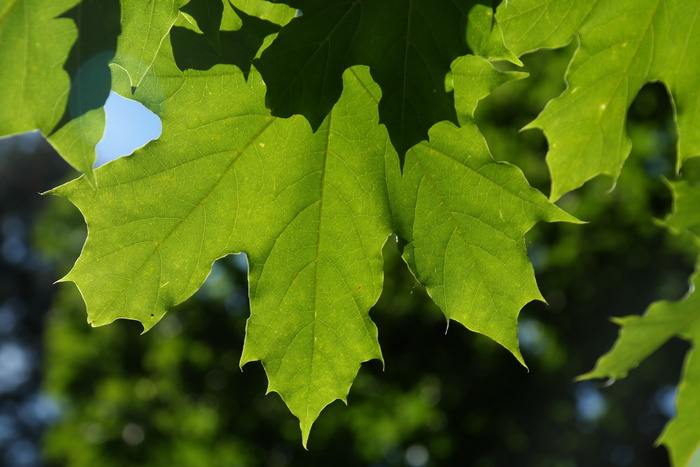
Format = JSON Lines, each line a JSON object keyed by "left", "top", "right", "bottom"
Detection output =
{"left": 392, "top": 119, "right": 576, "bottom": 364}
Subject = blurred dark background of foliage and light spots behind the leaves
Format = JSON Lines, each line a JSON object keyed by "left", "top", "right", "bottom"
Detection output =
{"left": 0, "top": 43, "right": 697, "bottom": 467}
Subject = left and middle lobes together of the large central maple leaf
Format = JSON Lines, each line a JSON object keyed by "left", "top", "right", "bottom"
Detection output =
{"left": 56, "top": 32, "right": 390, "bottom": 440}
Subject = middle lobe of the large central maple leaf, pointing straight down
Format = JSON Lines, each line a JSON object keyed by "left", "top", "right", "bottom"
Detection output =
{"left": 241, "top": 70, "right": 395, "bottom": 444}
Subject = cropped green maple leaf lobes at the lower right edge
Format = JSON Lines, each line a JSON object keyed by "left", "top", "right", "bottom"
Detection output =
{"left": 579, "top": 182, "right": 700, "bottom": 466}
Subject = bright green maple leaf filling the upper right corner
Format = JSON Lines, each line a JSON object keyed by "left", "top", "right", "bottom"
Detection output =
{"left": 508, "top": 0, "right": 700, "bottom": 199}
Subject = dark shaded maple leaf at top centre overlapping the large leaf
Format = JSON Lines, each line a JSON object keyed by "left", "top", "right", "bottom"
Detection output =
{"left": 256, "top": 0, "right": 517, "bottom": 161}
